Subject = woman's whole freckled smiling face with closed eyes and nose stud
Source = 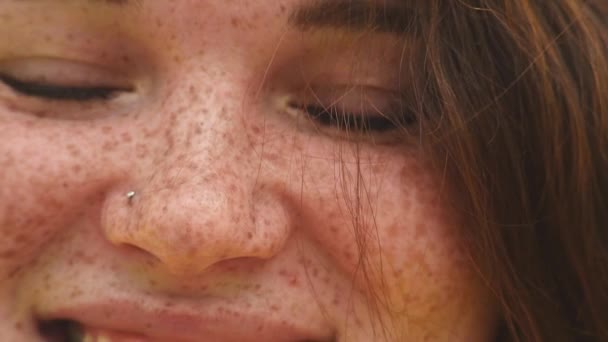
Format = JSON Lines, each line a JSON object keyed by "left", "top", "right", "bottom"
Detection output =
{"left": 0, "top": 0, "right": 496, "bottom": 342}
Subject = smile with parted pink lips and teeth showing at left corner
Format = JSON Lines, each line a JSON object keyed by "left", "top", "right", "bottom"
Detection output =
{"left": 38, "top": 308, "right": 336, "bottom": 342}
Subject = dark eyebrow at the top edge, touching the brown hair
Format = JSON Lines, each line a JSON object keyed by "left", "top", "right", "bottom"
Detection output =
{"left": 289, "top": 0, "right": 417, "bottom": 35}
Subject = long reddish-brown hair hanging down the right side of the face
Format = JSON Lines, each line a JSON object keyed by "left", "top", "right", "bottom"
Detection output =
{"left": 372, "top": 0, "right": 608, "bottom": 342}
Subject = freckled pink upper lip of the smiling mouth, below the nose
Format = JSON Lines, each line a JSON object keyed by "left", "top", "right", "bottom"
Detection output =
{"left": 39, "top": 299, "right": 333, "bottom": 342}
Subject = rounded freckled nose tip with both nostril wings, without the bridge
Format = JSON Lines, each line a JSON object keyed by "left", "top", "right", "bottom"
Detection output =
{"left": 104, "top": 180, "right": 289, "bottom": 276}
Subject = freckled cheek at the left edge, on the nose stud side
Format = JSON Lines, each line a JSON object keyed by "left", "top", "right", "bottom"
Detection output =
{"left": 0, "top": 118, "right": 133, "bottom": 281}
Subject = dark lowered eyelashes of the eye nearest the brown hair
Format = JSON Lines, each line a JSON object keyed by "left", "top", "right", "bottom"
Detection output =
{"left": 295, "top": 105, "right": 416, "bottom": 133}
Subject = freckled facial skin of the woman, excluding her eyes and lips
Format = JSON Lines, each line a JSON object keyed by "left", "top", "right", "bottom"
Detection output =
{"left": 0, "top": 0, "right": 495, "bottom": 342}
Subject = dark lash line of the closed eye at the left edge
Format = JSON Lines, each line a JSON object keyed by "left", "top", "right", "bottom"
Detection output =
{"left": 0, "top": 75, "right": 129, "bottom": 102}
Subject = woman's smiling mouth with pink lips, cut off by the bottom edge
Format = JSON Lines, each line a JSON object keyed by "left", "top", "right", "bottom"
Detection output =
{"left": 32, "top": 298, "right": 337, "bottom": 342}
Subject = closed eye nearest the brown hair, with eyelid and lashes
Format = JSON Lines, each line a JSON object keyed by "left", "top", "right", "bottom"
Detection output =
{"left": 289, "top": 86, "right": 417, "bottom": 138}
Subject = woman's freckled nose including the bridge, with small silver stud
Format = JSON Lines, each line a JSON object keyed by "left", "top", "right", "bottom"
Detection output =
{"left": 102, "top": 92, "right": 290, "bottom": 276}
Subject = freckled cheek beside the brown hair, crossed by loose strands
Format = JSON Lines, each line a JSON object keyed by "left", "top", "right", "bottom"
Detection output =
{"left": 282, "top": 142, "right": 486, "bottom": 326}
